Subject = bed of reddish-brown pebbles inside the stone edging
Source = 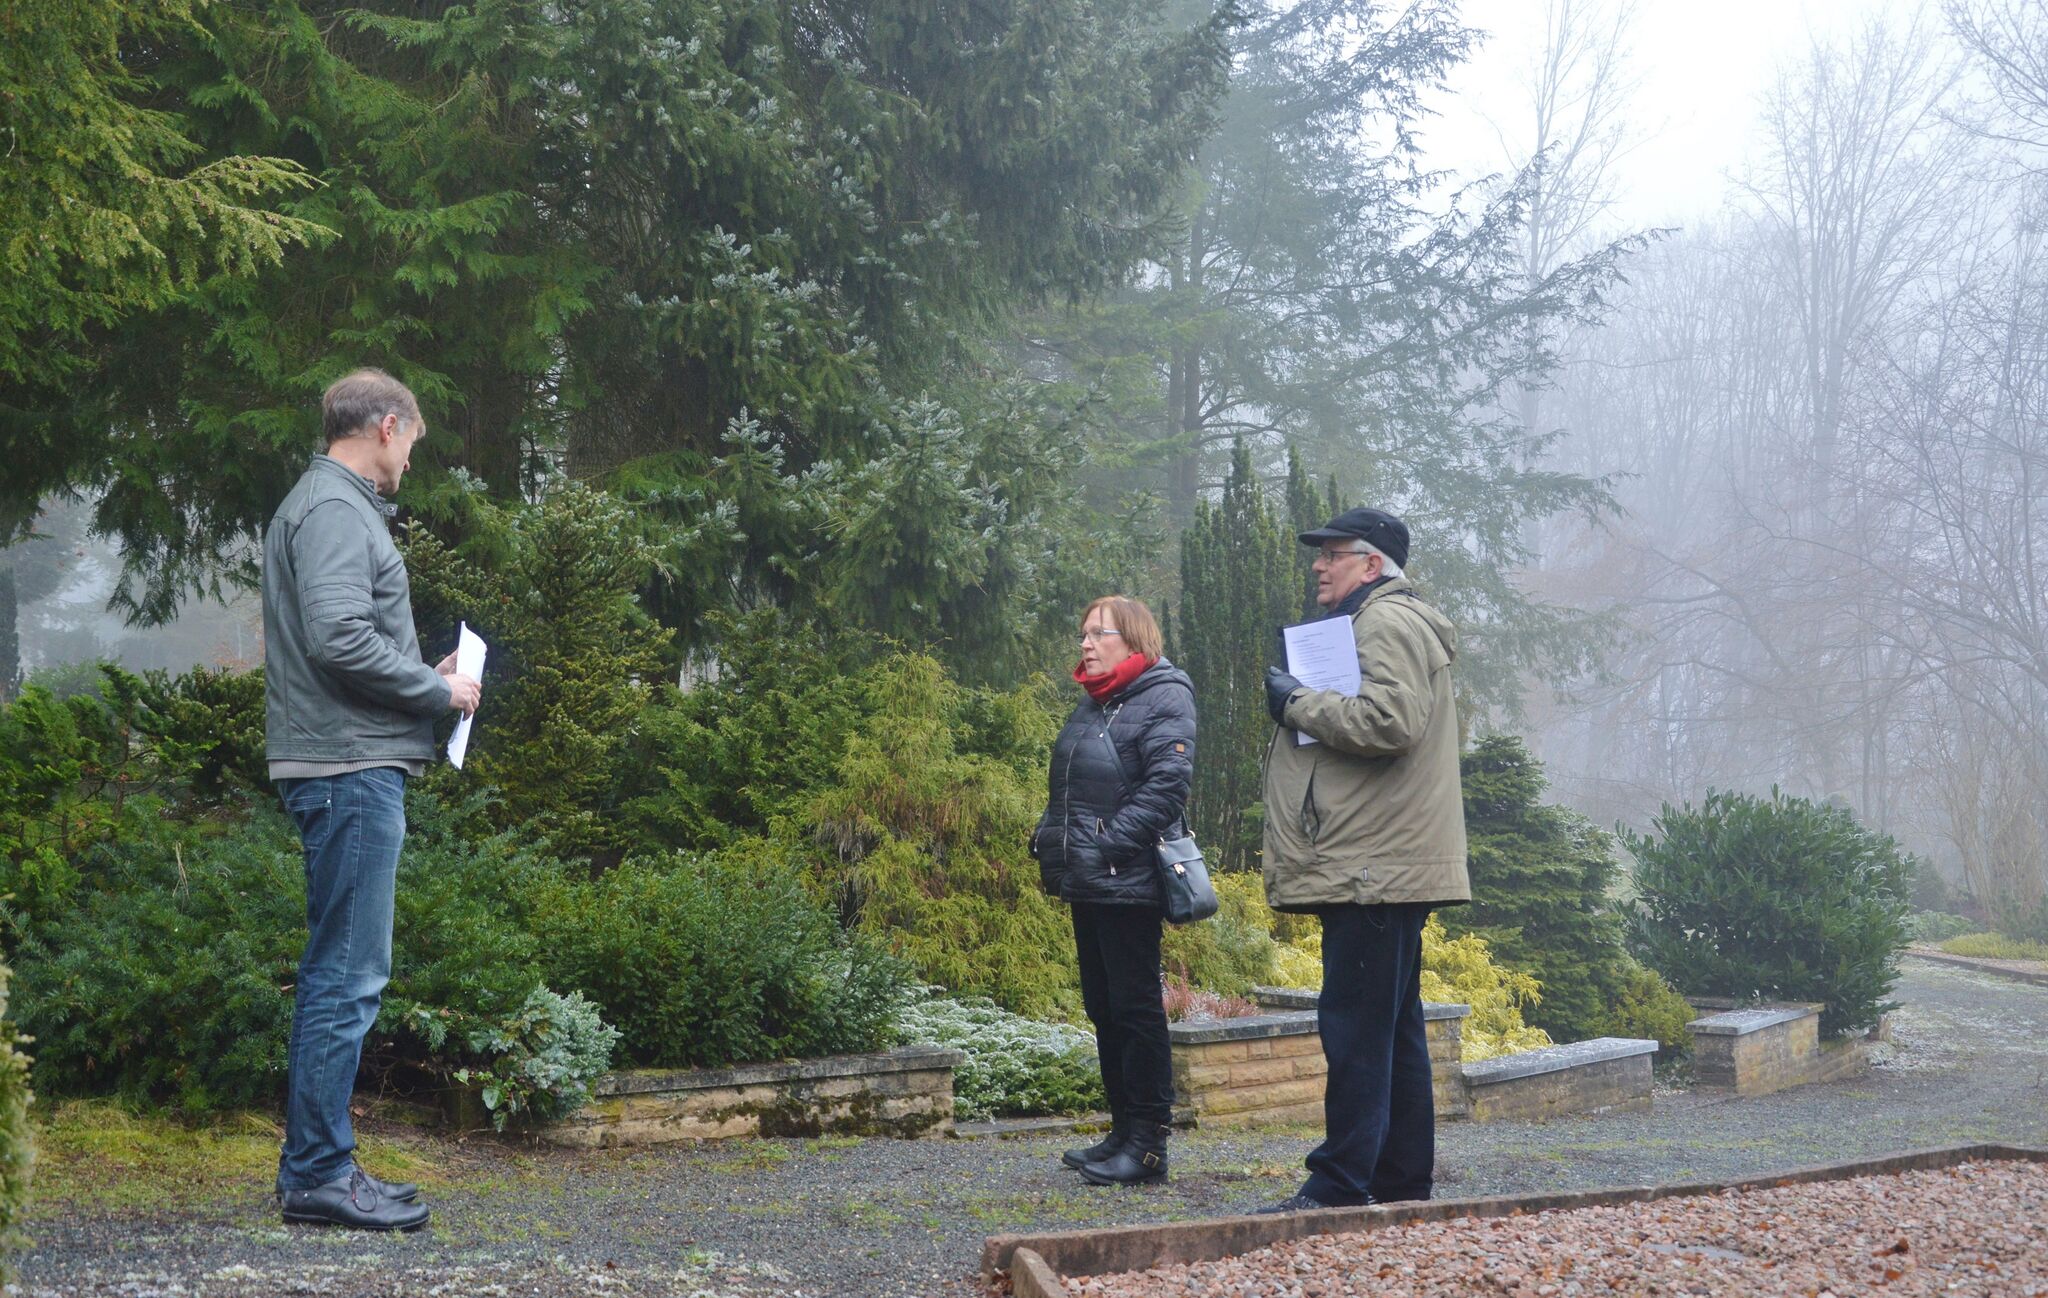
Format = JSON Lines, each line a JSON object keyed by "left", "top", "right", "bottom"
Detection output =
{"left": 1065, "top": 1163, "right": 2048, "bottom": 1298}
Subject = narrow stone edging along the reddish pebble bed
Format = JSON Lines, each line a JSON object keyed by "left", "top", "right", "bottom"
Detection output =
{"left": 981, "top": 1144, "right": 2048, "bottom": 1298}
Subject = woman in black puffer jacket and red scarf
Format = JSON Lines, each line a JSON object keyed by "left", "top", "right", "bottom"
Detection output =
{"left": 1030, "top": 596, "right": 1194, "bottom": 1185}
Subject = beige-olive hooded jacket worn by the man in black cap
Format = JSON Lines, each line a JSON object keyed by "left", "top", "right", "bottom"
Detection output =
{"left": 1266, "top": 577, "right": 1473, "bottom": 911}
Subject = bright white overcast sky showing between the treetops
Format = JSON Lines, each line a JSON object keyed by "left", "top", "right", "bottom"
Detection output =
{"left": 1425, "top": 0, "right": 1908, "bottom": 227}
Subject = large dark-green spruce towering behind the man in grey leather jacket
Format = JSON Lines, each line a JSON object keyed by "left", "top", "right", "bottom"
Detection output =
{"left": 0, "top": 0, "right": 1237, "bottom": 655}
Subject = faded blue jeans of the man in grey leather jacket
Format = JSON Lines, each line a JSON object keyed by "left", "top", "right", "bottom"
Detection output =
{"left": 276, "top": 766, "right": 406, "bottom": 1189}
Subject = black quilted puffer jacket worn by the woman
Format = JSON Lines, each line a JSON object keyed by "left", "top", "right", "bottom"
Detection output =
{"left": 1030, "top": 657, "right": 1194, "bottom": 907}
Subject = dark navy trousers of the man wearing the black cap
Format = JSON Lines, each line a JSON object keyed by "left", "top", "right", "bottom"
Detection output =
{"left": 1300, "top": 905, "right": 1436, "bottom": 1208}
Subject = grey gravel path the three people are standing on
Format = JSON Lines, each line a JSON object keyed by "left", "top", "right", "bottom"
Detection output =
{"left": 23, "top": 962, "right": 2048, "bottom": 1298}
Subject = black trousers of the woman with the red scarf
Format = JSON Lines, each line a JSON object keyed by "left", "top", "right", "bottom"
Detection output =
{"left": 1073, "top": 901, "right": 1174, "bottom": 1126}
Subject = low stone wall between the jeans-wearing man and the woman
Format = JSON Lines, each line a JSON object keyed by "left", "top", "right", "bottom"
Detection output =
{"left": 539, "top": 1046, "right": 967, "bottom": 1149}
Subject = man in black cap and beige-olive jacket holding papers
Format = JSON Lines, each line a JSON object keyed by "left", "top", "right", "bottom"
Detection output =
{"left": 1266, "top": 510, "right": 1473, "bottom": 1212}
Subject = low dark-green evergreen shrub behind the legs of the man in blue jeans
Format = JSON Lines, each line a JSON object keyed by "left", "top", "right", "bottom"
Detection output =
{"left": 16, "top": 794, "right": 602, "bottom": 1114}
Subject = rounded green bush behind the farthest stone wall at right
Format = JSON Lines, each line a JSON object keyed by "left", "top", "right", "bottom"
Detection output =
{"left": 1624, "top": 790, "right": 1911, "bottom": 1036}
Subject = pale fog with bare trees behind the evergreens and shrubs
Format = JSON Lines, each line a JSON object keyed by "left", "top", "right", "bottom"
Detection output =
{"left": 18, "top": 0, "right": 2048, "bottom": 901}
